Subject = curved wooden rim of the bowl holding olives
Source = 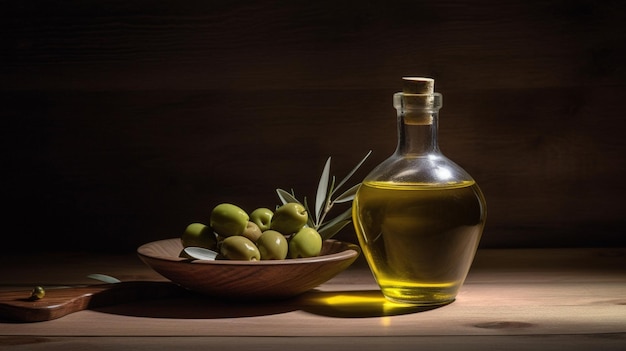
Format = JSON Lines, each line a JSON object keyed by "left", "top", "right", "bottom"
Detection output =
{"left": 137, "top": 238, "right": 361, "bottom": 266}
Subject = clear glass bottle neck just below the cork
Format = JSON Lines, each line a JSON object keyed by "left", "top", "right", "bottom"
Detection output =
{"left": 396, "top": 113, "right": 439, "bottom": 157}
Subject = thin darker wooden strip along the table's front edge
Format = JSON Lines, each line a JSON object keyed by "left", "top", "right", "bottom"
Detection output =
{"left": 0, "top": 334, "right": 624, "bottom": 351}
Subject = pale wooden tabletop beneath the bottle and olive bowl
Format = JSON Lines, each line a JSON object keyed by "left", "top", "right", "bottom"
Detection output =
{"left": 0, "top": 248, "right": 626, "bottom": 351}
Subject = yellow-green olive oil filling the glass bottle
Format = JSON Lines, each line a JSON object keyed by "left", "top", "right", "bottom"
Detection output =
{"left": 352, "top": 181, "right": 486, "bottom": 305}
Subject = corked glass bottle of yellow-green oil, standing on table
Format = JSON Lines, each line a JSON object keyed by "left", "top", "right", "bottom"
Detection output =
{"left": 352, "top": 77, "right": 486, "bottom": 306}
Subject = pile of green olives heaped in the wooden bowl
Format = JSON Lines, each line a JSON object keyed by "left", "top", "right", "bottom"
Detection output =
{"left": 181, "top": 202, "right": 322, "bottom": 261}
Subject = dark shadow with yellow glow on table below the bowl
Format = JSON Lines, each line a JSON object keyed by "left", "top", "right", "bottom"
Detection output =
{"left": 93, "top": 290, "right": 442, "bottom": 319}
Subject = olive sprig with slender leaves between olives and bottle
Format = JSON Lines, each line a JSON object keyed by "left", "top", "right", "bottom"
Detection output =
{"left": 276, "top": 150, "right": 372, "bottom": 240}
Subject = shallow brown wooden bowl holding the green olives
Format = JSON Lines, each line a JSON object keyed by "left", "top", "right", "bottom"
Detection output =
{"left": 137, "top": 238, "right": 361, "bottom": 300}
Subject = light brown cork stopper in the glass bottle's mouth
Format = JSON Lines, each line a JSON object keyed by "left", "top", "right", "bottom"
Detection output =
{"left": 402, "top": 77, "right": 435, "bottom": 125}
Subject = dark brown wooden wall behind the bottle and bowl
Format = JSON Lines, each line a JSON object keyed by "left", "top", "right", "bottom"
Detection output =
{"left": 0, "top": 0, "right": 626, "bottom": 252}
